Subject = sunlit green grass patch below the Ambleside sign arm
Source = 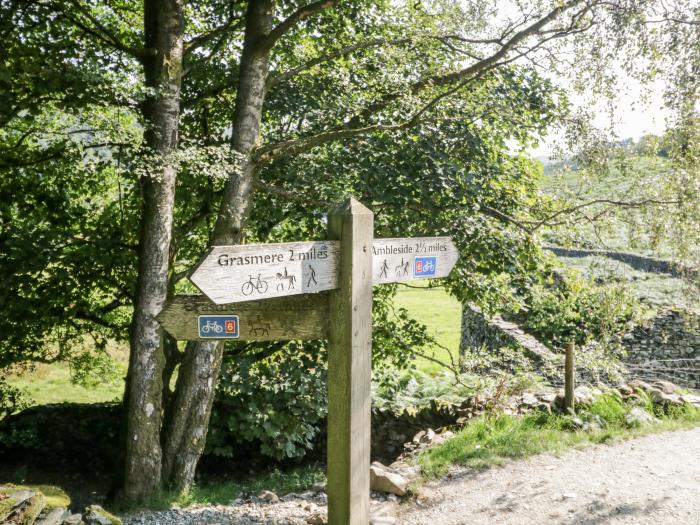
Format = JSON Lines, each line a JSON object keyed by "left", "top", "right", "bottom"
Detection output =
{"left": 396, "top": 281, "right": 462, "bottom": 375}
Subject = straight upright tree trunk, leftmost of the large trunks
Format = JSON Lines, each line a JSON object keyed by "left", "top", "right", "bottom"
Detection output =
{"left": 123, "top": 0, "right": 184, "bottom": 501}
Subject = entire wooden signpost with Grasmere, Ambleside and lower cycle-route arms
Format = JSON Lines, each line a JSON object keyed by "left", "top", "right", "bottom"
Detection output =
{"left": 158, "top": 198, "right": 458, "bottom": 525}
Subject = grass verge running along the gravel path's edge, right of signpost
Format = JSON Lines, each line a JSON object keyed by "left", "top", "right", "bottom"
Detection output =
{"left": 418, "top": 394, "right": 700, "bottom": 478}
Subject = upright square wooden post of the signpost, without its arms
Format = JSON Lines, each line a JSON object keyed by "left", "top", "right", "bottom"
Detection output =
{"left": 328, "top": 198, "right": 374, "bottom": 525}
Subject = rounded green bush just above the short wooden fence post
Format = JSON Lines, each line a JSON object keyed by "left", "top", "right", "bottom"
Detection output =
{"left": 523, "top": 269, "right": 635, "bottom": 348}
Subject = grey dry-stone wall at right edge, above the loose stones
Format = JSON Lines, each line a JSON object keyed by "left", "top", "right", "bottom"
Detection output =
{"left": 622, "top": 309, "right": 700, "bottom": 389}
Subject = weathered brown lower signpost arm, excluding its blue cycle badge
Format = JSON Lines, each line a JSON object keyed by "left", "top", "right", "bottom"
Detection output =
{"left": 157, "top": 292, "right": 329, "bottom": 341}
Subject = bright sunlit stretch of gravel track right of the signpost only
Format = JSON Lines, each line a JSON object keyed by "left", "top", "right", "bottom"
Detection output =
{"left": 394, "top": 428, "right": 700, "bottom": 525}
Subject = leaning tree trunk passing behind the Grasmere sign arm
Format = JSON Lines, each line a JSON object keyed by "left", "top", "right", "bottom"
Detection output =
{"left": 163, "top": 0, "right": 274, "bottom": 490}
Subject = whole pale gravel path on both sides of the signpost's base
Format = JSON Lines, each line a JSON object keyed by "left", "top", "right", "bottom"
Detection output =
{"left": 124, "top": 428, "right": 700, "bottom": 525}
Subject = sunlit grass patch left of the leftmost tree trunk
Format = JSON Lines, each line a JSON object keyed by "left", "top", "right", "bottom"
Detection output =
{"left": 7, "top": 363, "right": 124, "bottom": 405}
